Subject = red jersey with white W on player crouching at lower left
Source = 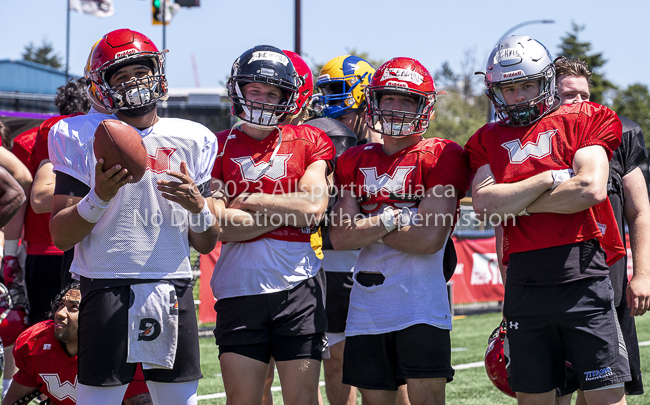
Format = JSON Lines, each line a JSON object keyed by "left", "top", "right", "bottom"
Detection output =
{"left": 13, "top": 321, "right": 149, "bottom": 405}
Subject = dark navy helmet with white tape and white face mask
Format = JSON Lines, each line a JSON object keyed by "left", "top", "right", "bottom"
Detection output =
{"left": 227, "top": 45, "right": 300, "bottom": 127}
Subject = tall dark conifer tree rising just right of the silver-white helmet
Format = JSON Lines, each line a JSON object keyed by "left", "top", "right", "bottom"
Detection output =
{"left": 559, "top": 23, "right": 616, "bottom": 104}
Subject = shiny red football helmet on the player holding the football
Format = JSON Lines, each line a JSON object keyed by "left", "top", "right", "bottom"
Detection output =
{"left": 90, "top": 29, "right": 168, "bottom": 112}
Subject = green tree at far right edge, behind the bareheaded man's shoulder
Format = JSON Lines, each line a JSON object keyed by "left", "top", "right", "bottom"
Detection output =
{"left": 612, "top": 83, "right": 650, "bottom": 145}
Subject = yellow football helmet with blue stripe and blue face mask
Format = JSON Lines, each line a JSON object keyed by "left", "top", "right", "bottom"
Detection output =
{"left": 314, "top": 55, "right": 375, "bottom": 118}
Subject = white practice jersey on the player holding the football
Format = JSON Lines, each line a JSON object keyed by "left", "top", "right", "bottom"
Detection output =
{"left": 49, "top": 113, "right": 217, "bottom": 279}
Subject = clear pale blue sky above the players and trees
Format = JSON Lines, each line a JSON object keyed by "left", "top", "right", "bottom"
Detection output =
{"left": 0, "top": 0, "right": 650, "bottom": 91}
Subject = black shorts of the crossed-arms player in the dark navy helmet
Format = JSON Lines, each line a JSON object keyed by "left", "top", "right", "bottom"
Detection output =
{"left": 214, "top": 276, "right": 327, "bottom": 363}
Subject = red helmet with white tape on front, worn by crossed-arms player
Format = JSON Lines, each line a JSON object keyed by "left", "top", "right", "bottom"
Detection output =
{"left": 365, "top": 58, "right": 446, "bottom": 136}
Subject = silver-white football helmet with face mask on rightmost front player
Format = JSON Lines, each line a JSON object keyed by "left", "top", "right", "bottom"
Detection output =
{"left": 485, "top": 35, "right": 557, "bottom": 127}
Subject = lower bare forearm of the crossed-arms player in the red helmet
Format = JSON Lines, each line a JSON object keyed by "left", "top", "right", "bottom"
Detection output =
{"left": 382, "top": 225, "right": 451, "bottom": 254}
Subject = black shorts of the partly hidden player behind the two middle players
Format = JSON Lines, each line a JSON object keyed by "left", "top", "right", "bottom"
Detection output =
{"left": 325, "top": 271, "right": 354, "bottom": 333}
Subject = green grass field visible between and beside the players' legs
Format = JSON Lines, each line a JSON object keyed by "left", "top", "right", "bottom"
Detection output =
{"left": 199, "top": 313, "right": 650, "bottom": 405}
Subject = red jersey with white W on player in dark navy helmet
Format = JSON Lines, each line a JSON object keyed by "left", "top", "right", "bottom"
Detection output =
{"left": 212, "top": 125, "right": 335, "bottom": 242}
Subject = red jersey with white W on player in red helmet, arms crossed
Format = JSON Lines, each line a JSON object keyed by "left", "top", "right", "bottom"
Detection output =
{"left": 336, "top": 138, "right": 471, "bottom": 211}
